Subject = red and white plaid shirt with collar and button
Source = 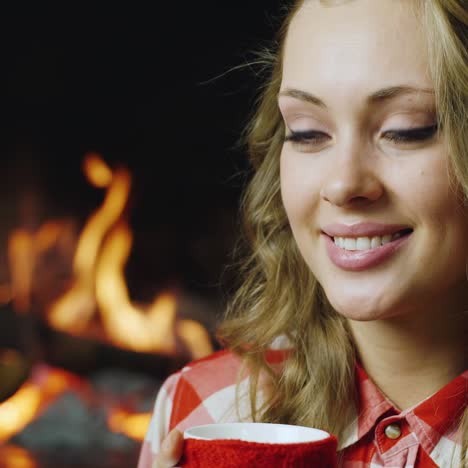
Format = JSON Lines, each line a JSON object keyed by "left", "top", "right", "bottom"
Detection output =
{"left": 138, "top": 351, "right": 468, "bottom": 468}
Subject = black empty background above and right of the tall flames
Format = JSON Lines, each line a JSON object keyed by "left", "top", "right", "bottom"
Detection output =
{"left": 0, "top": 0, "right": 284, "bottom": 302}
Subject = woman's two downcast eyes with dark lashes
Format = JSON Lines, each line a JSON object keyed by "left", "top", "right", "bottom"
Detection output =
{"left": 284, "top": 124, "right": 439, "bottom": 146}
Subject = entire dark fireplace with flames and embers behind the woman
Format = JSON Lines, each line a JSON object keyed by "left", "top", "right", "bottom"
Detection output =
{"left": 0, "top": 0, "right": 284, "bottom": 468}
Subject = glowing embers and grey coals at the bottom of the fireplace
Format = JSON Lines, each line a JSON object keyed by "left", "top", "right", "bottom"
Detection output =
{"left": 0, "top": 346, "right": 161, "bottom": 468}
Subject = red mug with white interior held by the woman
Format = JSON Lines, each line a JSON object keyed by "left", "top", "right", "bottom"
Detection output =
{"left": 179, "top": 423, "right": 337, "bottom": 468}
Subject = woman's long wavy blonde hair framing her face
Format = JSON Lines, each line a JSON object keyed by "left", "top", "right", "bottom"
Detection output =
{"left": 219, "top": 0, "right": 468, "bottom": 463}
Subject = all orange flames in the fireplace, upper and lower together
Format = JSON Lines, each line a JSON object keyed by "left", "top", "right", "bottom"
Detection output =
{"left": 0, "top": 154, "right": 217, "bottom": 458}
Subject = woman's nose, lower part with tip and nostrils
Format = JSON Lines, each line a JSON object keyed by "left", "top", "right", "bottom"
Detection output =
{"left": 320, "top": 156, "right": 384, "bottom": 207}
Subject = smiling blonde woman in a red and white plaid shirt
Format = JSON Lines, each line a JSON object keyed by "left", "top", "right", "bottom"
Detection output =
{"left": 139, "top": 0, "right": 468, "bottom": 468}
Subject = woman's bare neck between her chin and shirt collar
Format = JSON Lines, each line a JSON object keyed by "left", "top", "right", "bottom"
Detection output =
{"left": 349, "top": 313, "right": 468, "bottom": 410}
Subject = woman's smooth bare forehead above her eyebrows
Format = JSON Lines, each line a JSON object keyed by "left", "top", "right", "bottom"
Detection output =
{"left": 283, "top": 0, "right": 431, "bottom": 98}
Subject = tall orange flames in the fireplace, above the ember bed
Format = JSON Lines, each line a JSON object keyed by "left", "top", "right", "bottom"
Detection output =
{"left": 5, "top": 153, "right": 213, "bottom": 358}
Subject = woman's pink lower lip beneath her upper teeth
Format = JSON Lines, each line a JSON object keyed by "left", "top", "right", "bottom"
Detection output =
{"left": 322, "top": 231, "right": 412, "bottom": 271}
